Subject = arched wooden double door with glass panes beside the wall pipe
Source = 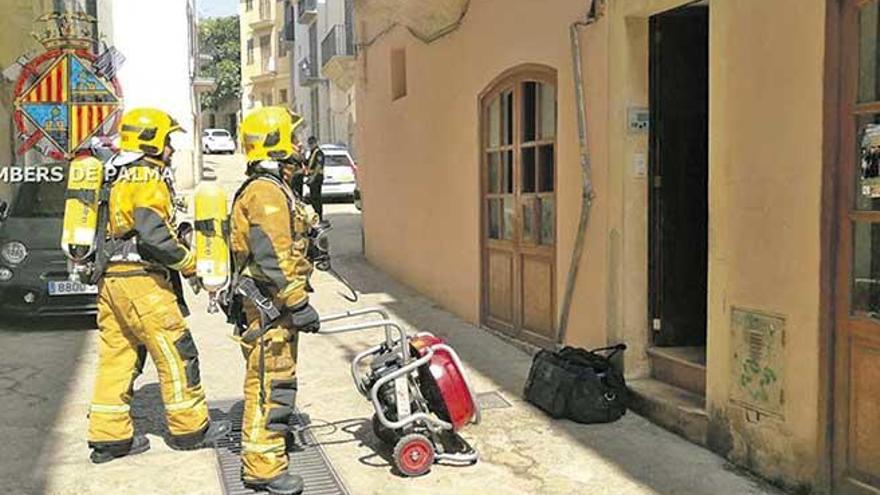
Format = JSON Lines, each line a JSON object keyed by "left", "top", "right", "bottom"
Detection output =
{"left": 481, "top": 67, "right": 557, "bottom": 346}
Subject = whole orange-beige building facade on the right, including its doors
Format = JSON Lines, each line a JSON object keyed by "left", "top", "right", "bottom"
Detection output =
{"left": 355, "top": 0, "right": 880, "bottom": 494}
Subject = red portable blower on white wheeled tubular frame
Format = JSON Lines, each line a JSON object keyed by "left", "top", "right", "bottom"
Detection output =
{"left": 320, "top": 308, "right": 480, "bottom": 476}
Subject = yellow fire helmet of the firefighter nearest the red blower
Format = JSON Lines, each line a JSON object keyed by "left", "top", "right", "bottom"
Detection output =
{"left": 241, "top": 107, "right": 303, "bottom": 163}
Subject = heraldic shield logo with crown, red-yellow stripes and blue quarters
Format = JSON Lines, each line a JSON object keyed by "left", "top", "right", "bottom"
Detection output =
{"left": 15, "top": 12, "right": 122, "bottom": 160}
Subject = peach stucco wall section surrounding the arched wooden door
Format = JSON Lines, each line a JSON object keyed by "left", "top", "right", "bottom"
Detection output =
{"left": 357, "top": 0, "right": 607, "bottom": 352}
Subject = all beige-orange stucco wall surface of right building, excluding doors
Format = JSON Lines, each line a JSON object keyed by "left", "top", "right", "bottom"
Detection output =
{"left": 358, "top": 0, "right": 828, "bottom": 486}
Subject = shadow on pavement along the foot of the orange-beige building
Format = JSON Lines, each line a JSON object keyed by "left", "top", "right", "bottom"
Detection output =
{"left": 318, "top": 209, "right": 776, "bottom": 495}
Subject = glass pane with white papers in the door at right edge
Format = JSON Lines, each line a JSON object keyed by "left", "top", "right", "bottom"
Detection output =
{"left": 855, "top": 114, "right": 880, "bottom": 211}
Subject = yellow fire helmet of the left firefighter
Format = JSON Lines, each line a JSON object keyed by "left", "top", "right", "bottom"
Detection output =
{"left": 119, "top": 108, "right": 186, "bottom": 156}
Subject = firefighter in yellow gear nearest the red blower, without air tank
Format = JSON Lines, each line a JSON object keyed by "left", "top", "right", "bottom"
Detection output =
{"left": 230, "top": 107, "right": 320, "bottom": 495}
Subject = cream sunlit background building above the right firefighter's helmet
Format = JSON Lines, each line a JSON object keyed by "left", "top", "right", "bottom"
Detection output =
{"left": 239, "top": 0, "right": 294, "bottom": 114}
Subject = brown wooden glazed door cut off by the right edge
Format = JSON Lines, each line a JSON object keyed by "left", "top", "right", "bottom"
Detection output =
{"left": 829, "top": 0, "right": 880, "bottom": 495}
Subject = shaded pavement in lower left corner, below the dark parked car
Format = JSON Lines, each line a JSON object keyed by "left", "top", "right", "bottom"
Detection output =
{"left": 0, "top": 317, "right": 95, "bottom": 494}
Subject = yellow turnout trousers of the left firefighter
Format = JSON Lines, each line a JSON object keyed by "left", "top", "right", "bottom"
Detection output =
{"left": 88, "top": 264, "right": 208, "bottom": 449}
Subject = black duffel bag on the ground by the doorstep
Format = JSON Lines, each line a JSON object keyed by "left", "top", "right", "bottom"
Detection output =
{"left": 524, "top": 344, "right": 627, "bottom": 423}
